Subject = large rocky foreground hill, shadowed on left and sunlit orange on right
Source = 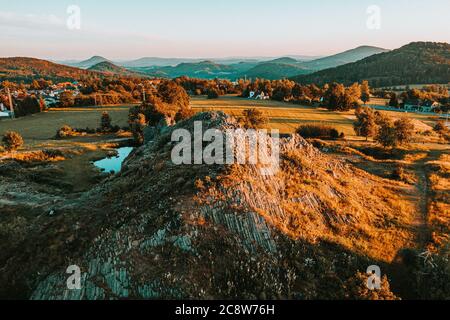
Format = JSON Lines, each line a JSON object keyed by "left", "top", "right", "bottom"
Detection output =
{"left": 0, "top": 112, "right": 413, "bottom": 299}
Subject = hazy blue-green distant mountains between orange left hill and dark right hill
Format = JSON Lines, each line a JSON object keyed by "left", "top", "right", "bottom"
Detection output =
{"left": 59, "top": 46, "right": 387, "bottom": 80}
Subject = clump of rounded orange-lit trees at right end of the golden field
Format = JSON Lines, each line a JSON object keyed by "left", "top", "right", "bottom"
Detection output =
{"left": 354, "top": 107, "right": 415, "bottom": 148}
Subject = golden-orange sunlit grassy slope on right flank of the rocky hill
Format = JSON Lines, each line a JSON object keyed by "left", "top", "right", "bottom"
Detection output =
{"left": 199, "top": 140, "right": 417, "bottom": 262}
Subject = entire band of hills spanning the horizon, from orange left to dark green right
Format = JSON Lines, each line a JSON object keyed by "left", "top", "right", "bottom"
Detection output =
{"left": 0, "top": 42, "right": 450, "bottom": 87}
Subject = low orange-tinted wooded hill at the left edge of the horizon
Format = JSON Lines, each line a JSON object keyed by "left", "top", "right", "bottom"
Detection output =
{"left": 0, "top": 57, "right": 98, "bottom": 83}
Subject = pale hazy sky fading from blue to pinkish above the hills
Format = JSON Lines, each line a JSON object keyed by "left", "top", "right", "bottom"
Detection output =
{"left": 0, "top": 0, "right": 450, "bottom": 59}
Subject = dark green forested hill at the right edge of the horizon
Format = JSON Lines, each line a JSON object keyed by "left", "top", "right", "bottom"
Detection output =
{"left": 292, "top": 42, "right": 450, "bottom": 87}
